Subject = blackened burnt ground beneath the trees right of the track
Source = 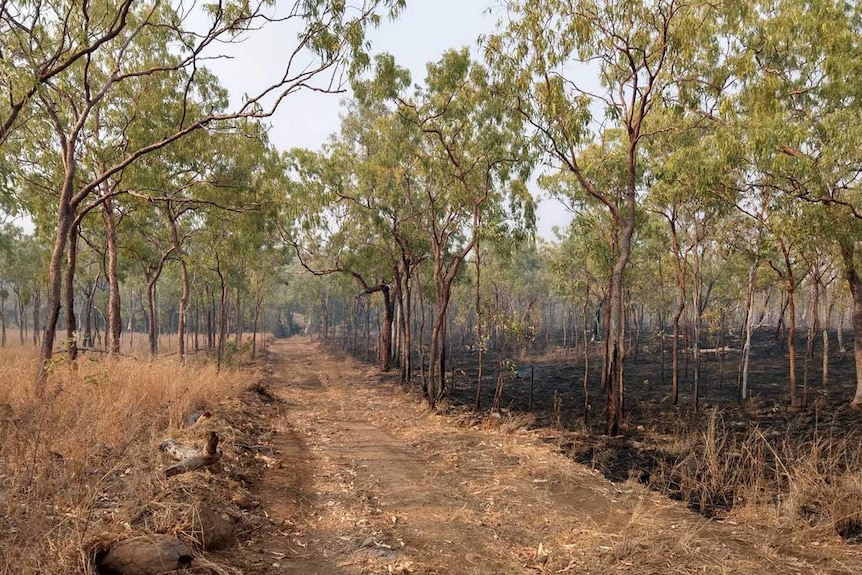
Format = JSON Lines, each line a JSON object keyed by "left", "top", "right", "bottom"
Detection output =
{"left": 442, "top": 328, "right": 862, "bottom": 532}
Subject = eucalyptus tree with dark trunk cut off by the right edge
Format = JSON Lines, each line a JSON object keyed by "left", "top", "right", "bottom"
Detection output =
{"left": 727, "top": 0, "right": 862, "bottom": 406}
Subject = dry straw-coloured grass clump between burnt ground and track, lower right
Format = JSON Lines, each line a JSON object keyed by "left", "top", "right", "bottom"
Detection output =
{"left": 651, "top": 413, "right": 862, "bottom": 543}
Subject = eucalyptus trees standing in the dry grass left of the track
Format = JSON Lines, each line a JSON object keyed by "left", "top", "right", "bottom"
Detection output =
{"left": 0, "top": 0, "right": 403, "bottom": 382}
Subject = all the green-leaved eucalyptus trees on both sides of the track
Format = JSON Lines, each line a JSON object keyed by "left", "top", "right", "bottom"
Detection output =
{"left": 0, "top": 0, "right": 862, "bottom": 435}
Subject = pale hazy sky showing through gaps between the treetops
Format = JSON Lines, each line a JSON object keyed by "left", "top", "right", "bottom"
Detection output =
{"left": 210, "top": 0, "right": 570, "bottom": 238}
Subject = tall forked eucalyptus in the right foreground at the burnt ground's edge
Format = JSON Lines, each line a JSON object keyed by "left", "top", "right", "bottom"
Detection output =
{"left": 487, "top": 0, "right": 721, "bottom": 435}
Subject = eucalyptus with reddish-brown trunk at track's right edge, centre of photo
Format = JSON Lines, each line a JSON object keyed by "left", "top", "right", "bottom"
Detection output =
{"left": 395, "top": 49, "right": 535, "bottom": 406}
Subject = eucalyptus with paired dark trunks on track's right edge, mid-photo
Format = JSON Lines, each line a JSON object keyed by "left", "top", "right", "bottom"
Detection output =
{"left": 322, "top": 60, "right": 428, "bottom": 381}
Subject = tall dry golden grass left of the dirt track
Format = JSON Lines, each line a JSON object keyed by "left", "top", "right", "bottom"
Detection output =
{"left": 0, "top": 347, "right": 254, "bottom": 575}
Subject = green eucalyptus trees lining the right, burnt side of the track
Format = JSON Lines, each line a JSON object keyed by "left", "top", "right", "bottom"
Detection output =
{"left": 280, "top": 0, "right": 862, "bottom": 435}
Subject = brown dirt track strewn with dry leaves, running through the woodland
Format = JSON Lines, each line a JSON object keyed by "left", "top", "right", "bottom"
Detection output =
{"left": 235, "top": 338, "right": 858, "bottom": 575}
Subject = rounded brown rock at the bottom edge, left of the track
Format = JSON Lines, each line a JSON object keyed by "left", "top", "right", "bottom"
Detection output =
{"left": 97, "top": 535, "right": 193, "bottom": 575}
